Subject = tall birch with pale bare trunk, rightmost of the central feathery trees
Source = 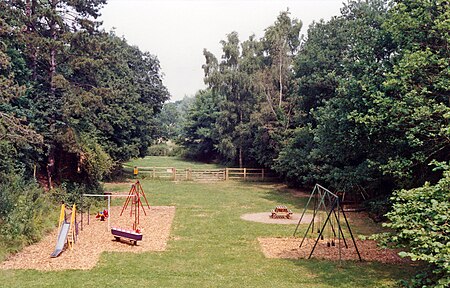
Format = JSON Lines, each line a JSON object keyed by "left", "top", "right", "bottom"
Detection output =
{"left": 250, "top": 11, "right": 302, "bottom": 167}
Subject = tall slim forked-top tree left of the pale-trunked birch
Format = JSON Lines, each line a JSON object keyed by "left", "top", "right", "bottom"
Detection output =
{"left": 203, "top": 32, "right": 255, "bottom": 167}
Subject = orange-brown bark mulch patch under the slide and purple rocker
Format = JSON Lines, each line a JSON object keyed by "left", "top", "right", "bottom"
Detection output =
{"left": 0, "top": 206, "right": 175, "bottom": 271}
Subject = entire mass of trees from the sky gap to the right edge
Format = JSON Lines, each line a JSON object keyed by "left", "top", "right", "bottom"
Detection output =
{"left": 183, "top": 0, "right": 450, "bottom": 207}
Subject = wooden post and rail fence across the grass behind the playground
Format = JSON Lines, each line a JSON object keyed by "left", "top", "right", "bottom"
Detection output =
{"left": 125, "top": 167, "right": 276, "bottom": 181}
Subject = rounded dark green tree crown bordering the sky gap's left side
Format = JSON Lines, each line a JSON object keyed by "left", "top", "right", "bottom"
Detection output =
{"left": 64, "top": 33, "right": 168, "bottom": 161}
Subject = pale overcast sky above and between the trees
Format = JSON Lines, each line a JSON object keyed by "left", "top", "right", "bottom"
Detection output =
{"left": 100, "top": 0, "right": 346, "bottom": 101}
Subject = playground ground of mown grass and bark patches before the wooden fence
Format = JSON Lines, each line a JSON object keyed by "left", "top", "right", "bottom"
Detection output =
{"left": 0, "top": 159, "right": 416, "bottom": 288}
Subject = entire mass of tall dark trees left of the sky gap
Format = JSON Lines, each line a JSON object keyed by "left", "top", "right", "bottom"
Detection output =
{"left": 0, "top": 0, "right": 169, "bottom": 186}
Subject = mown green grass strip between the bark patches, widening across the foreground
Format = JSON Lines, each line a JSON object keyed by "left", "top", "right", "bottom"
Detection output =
{"left": 0, "top": 180, "right": 410, "bottom": 288}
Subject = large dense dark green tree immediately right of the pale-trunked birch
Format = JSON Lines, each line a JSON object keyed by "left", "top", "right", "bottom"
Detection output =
{"left": 275, "top": 1, "right": 392, "bottom": 193}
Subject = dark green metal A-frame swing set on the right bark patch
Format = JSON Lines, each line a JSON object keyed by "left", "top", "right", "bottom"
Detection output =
{"left": 293, "top": 184, "right": 362, "bottom": 261}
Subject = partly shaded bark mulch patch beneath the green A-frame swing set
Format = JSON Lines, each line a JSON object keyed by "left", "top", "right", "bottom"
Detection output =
{"left": 258, "top": 238, "right": 411, "bottom": 264}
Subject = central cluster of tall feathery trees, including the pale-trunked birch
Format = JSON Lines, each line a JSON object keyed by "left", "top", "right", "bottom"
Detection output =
{"left": 192, "top": 11, "right": 302, "bottom": 167}
